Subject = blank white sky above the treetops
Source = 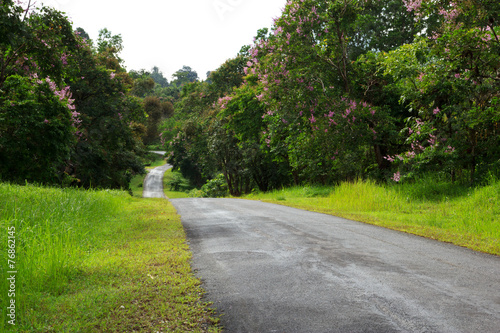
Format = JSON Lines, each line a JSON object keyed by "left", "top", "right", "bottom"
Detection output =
{"left": 40, "top": 0, "right": 286, "bottom": 81}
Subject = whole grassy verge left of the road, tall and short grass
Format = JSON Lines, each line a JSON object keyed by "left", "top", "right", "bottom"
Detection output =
{"left": 0, "top": 184, "right": 218, "bottom": 332}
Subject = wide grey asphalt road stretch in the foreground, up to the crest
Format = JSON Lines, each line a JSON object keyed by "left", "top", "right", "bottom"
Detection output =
{"left": 171, "top": 199, "right": 500, "bottom": 333}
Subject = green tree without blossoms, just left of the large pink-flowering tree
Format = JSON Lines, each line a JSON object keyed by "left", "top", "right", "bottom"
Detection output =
{"left": 213, "top": 83, "right": 290, "bottom": 196}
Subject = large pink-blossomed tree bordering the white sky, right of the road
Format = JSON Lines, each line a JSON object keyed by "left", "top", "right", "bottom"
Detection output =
{"left": 246, "top": 0, "right": 398, "bottom": 182}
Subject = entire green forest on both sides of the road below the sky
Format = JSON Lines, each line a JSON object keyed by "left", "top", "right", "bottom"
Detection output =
{"left": 0, "top": 0, "right": 500, "bottom": 196}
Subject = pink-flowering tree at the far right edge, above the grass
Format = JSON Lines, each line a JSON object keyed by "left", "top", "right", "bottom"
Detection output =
{"left": 385, "top": 1, "right": 500, "bottom": 182}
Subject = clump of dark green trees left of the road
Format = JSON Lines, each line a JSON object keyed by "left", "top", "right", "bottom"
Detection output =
{"left": 0, "top": 1, "right": 142, "bottom": 188}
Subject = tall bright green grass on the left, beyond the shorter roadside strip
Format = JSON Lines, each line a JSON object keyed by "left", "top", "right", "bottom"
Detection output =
{"left": 0, "top": 184, "right": 126, "bottom": 328}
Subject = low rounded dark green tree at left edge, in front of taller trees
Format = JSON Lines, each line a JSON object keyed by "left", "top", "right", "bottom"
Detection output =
{"left": 0, "top": 75, "right": 77, "bottom": 184}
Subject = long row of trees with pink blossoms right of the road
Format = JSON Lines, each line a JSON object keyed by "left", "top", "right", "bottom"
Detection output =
{"left": 162, "top": 0, "right": 500, "bottom": 196}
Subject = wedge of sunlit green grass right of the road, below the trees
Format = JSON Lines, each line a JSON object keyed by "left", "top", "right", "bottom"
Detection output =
{"left": 246, "top": 179, "right": 500, "bottom": 255}
